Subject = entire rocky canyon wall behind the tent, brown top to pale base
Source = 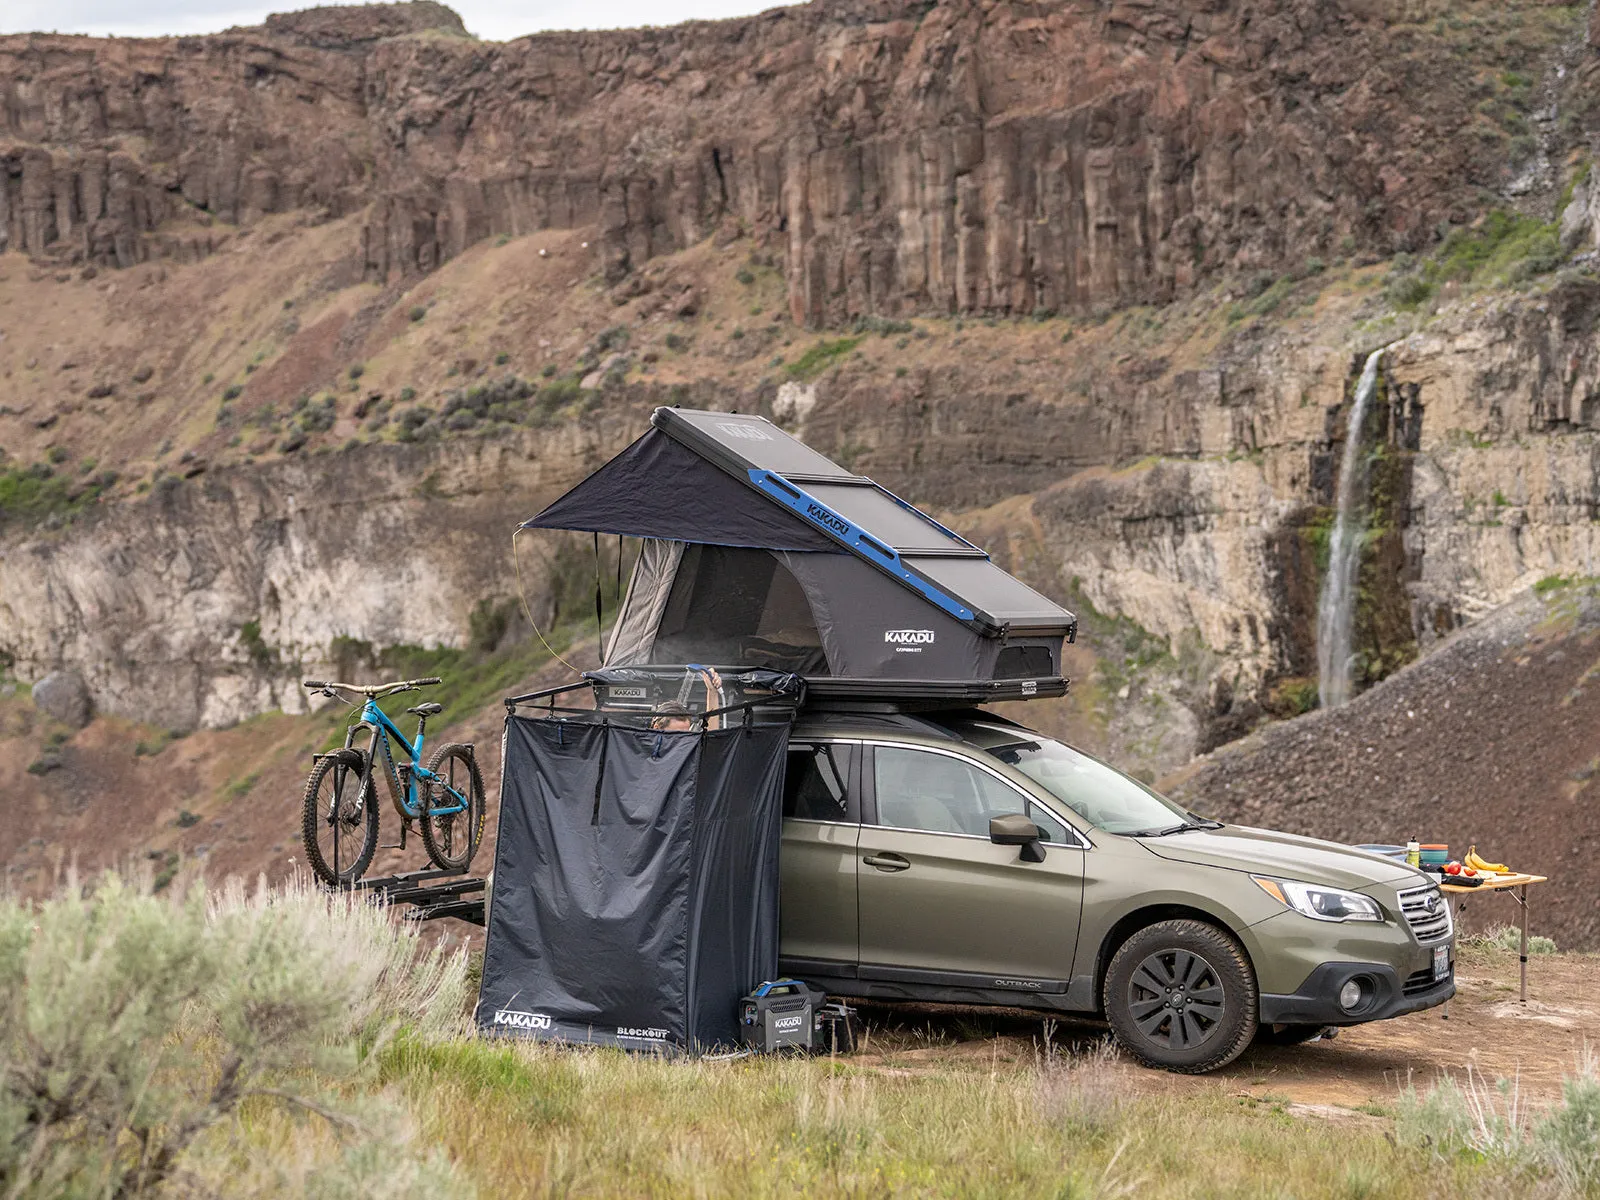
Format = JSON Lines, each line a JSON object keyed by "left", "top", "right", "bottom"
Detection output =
{"left": 0, "top": 0, "right": 1600, "bottom": 770}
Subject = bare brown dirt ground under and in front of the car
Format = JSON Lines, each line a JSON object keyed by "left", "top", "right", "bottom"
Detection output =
{"left": 851, "top": 946, "right": 1600, "bottom": 1120}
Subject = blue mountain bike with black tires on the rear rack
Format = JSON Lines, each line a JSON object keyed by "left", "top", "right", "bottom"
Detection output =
{"left": 301, "top": 677, "right": 485, "bottom": 886}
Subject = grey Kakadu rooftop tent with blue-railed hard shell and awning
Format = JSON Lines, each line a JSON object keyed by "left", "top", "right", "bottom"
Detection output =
{"left": 523, "top": 408, "right": 1077, "bottom": 702}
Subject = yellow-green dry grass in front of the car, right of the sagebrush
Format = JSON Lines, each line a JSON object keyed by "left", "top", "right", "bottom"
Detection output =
{"left": 368, "top": 1040, "right": 1529, "bottom": 1197}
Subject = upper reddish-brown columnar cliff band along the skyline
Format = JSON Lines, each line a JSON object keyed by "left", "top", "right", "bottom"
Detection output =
{"left": 0, "top": 0, "right": 1581, "bottom": 323}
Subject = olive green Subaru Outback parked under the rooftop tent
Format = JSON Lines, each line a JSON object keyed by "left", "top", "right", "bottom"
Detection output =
{"left": 781, "top": 710, "right": 1456, "bottom": 1072}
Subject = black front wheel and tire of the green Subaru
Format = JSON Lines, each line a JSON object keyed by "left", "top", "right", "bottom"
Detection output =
{"left": 1104, "top": 920, "right": 1258, "bottom": 1075}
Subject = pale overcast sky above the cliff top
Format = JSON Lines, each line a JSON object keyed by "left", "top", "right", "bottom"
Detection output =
{"left": 0, "top": 0, "right": 779, "bottom": 42}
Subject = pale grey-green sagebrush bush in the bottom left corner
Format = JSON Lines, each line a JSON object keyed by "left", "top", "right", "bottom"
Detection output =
{"left": 0, "top": 874, "right": 466, "bottom": 1197}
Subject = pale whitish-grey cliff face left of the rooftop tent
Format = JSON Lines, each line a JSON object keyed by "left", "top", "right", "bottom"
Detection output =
{"left": 0, "top": 410, "right": 636, "bottom": 730}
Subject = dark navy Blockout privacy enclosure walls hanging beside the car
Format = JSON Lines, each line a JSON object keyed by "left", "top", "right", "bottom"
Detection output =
{"left": 478, "top": 717, "right": 789, "bottom": 1051}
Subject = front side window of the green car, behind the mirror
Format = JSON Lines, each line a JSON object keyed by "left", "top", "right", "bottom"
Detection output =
{"left": 872, "top": 746, "right": 1070, "bottom": 842}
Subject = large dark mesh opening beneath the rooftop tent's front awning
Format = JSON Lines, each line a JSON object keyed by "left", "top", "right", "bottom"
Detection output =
{"left": 651, "top": 546, "right": 829, "bottom": 675}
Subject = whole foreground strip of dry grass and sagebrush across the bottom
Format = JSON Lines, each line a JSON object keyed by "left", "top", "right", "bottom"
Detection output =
{"left": 12, "top": 880, "right": 1600, "bottom": 1200}
